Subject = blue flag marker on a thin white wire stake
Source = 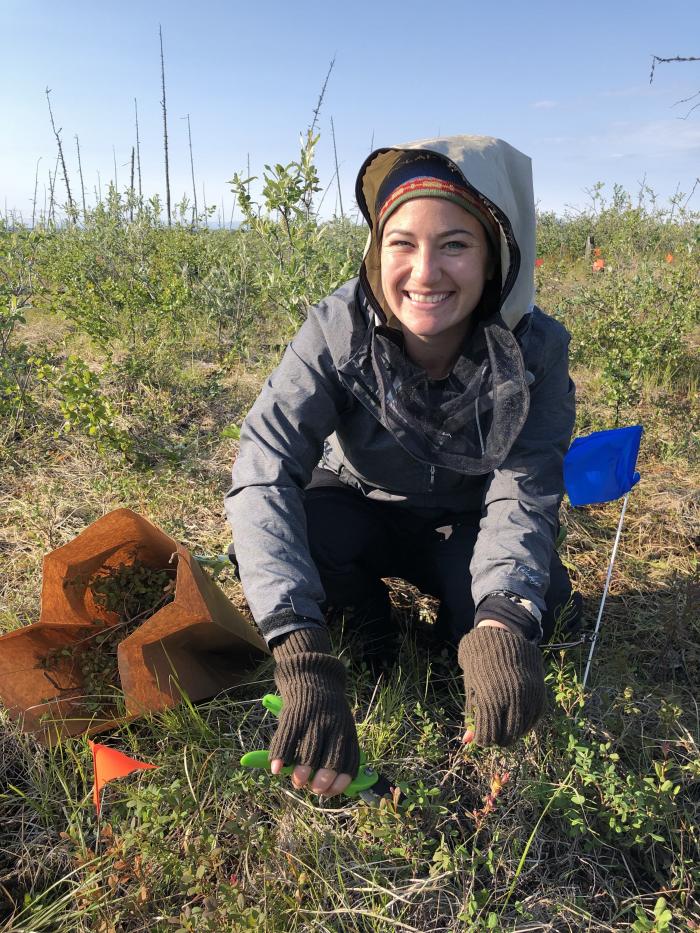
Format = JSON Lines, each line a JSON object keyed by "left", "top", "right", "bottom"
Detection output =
{"left": 564, "top": 424, "right": 643, "bottom": 687}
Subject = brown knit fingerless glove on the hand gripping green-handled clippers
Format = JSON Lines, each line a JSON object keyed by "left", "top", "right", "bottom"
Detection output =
{"left": 270, "top": 627, "right": 360, "bottom": 777}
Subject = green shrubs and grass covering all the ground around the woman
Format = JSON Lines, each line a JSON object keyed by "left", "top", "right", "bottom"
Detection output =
{"left": 0, "top": 144, "right": 700, "bottom": 933}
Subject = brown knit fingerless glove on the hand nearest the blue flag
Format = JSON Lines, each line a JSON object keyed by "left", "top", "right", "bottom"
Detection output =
{"left": 457, "top": 625, "right": 545, "bottom": 745}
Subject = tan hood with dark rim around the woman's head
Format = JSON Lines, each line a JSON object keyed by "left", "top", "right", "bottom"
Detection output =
{"left": 355, "top": 136, "right": 535, "bottom": 330}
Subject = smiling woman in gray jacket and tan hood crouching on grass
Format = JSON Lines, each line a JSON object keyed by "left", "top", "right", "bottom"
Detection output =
{"left": 226, "top": 136, "right": 574, "bottom": 796}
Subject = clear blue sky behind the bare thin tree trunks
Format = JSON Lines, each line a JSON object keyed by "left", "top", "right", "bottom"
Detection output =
{"left": 0, "top": 0, "right": 700, "bottom": 218}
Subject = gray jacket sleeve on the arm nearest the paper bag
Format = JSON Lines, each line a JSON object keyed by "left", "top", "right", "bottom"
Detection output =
{"left": 225, "top": 305, "right": 349, "bottom": 642}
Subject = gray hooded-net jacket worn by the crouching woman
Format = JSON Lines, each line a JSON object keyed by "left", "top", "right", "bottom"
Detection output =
{"left": 225, "top": 137, "right": 575, "bottom": 641}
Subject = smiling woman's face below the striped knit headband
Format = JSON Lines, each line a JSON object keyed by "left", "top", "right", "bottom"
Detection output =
{"left": 381, "top": 198, "right": 493, "bottom": 342}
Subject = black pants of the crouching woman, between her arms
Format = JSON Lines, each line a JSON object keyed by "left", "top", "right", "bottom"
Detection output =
{"left": 305, "top": 470, "right": 580, "bottom": 644}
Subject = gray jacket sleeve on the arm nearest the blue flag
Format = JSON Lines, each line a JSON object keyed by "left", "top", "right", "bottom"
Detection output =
{"left": 470, "top": 312, "right": 575, "bottom": 628}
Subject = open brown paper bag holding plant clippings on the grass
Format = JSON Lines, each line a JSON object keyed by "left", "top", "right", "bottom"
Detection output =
{"left": 0, "top": 509, "right": 269, "bottom": 742}
